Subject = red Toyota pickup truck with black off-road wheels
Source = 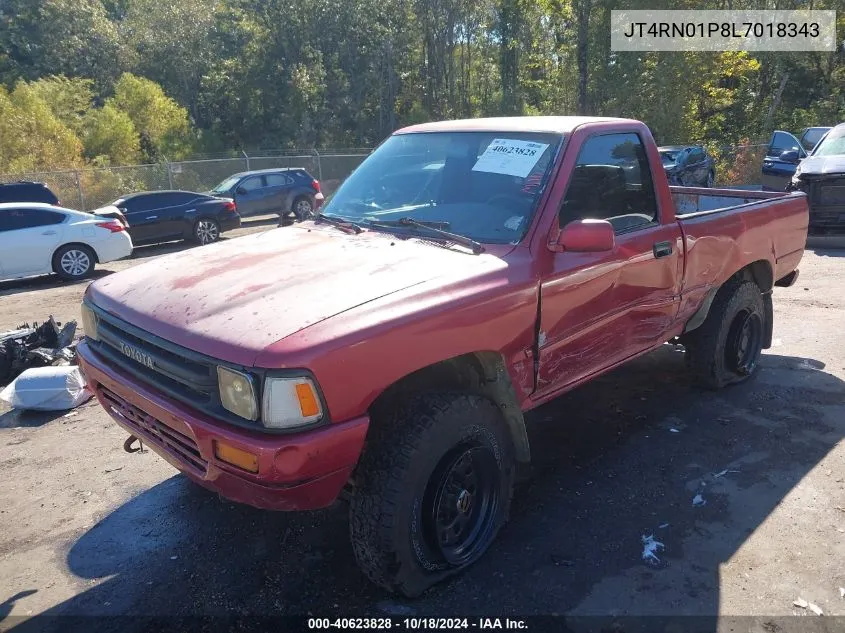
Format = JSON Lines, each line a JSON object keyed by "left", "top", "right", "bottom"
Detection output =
{"left": 79, "top": 117, "right": 808, "bottom": 596}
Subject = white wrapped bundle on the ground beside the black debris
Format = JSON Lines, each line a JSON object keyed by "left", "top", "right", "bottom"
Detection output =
{"left": 0, "top": 366, "right": 93, "bottom": 411}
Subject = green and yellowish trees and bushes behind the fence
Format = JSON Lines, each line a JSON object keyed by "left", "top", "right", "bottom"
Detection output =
{"left": 0, "top": 0, "right": 845, "bottom": 173}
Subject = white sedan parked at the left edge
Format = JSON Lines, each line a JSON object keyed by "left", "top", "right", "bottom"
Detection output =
{"left": 0, "top": 202, "right": 132, "bottom": 280}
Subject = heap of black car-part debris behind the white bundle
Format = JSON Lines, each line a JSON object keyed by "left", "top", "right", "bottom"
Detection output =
{"left": 0, "top": 316, "right": 76, "bottom": 383}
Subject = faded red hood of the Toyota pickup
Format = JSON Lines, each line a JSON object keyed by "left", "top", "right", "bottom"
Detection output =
{"left": 87, "top": 223, "right": 499, "bottom": 366}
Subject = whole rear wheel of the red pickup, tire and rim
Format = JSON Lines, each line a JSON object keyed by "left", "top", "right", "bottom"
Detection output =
{"left": 684, "top": 281, "right": 766, "bottom": 389}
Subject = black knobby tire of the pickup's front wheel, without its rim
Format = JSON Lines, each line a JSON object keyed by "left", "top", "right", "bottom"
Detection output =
{"left": 350, "top": 393, "right": 516, "bottom": 597}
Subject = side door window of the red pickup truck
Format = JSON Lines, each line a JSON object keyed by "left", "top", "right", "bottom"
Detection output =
{"left": 559, "top": 133, "right": 657, "bottom": 233}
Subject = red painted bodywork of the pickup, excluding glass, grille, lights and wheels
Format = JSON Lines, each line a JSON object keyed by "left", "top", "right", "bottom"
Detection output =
{"left": 80, "top": 117, "right": 808, "bottom": 509}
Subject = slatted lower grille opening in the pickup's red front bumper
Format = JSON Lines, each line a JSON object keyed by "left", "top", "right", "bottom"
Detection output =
{"left": 99, "top": 385, "right": 208, "bottom": 476}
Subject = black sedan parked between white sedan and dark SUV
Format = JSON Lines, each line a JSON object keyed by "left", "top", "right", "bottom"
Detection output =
{"left": 94, "top": 191, "right": 241, "bottom": 244}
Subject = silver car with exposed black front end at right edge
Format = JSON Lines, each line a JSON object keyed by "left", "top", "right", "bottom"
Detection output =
{"left": 786, "top": 123, "right": 845, "bottom": 235}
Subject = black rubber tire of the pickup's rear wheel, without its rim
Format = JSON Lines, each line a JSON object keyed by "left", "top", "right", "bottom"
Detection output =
{"left": 683, "top": 280, "right": 766, "bottom": 389}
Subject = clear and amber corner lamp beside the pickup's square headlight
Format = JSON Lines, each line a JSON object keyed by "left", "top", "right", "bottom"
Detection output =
{"left": 261, "top": 377, "right": 323, "bottom": 429}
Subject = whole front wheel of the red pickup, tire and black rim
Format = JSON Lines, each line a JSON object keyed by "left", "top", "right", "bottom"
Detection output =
{"left": 350, "top": 394, "right": 515, "bottom": 597}
